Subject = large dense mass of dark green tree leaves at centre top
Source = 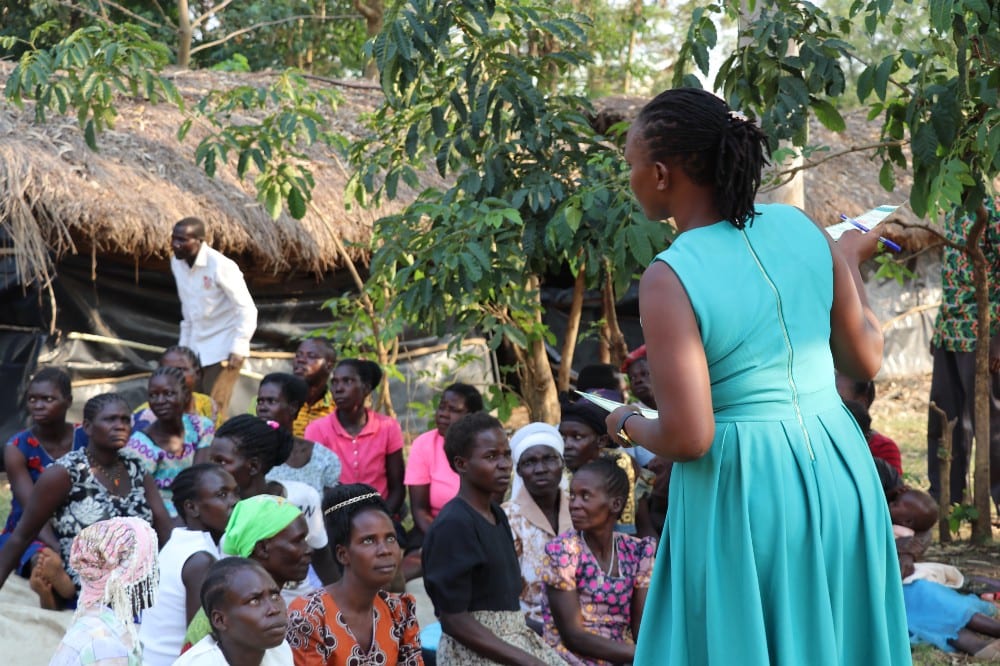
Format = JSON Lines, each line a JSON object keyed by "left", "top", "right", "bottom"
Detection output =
{"left": 351, "top": 0, "right": 662, "bottom": 374}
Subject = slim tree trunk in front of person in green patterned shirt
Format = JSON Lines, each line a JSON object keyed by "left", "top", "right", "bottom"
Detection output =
{"left": 965, "top": 203, "right": 993, "bottom": 543}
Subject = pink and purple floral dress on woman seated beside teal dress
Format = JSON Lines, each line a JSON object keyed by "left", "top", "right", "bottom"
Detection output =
{"left": 542, "top": 531, "right": 656, "bottom": 666}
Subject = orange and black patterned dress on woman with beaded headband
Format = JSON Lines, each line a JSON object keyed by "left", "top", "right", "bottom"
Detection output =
{"left": 286, "top": 589, "right": 424, "bottom": 666}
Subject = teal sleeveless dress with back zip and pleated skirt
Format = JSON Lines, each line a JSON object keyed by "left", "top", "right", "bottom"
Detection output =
{"left": 635, "top": 205, "right": 911, "bottom": 666}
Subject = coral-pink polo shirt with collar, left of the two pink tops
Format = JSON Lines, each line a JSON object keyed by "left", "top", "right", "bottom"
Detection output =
{"left": 305, "top": 409, "right": 403, "bottom": 498}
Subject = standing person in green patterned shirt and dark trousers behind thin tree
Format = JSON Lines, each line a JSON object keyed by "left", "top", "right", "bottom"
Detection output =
{"left": 927, "top": 197, "right": 1000, "bottom": 505}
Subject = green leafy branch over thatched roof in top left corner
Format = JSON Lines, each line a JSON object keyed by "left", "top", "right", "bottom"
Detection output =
{"left": 2, "top": 22, "right": 183, "bottom": 150}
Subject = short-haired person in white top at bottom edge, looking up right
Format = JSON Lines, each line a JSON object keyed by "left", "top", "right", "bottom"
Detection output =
{"left": 174, "top": 557, "right": 292, "bottom": 666}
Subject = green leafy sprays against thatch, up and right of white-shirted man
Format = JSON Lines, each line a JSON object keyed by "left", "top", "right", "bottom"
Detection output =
{"left": 177, "top": 71, "right": 346, "bottom": 219}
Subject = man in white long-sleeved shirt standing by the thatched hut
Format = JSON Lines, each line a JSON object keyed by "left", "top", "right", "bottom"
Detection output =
{"left": 170, "top": 217, "right": 257, "bottom": 418}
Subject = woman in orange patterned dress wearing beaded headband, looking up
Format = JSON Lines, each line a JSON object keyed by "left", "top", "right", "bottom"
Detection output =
{"left": 287, "top": 483, "right": 423, "bottom": 666}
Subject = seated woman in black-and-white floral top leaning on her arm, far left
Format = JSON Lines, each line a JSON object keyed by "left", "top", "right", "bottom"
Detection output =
{"left": 0, "top": 393, "right": 172, "bottom": 601}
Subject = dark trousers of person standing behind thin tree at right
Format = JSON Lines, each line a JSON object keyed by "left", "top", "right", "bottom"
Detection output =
{"left": 927, "top": 348, "right": 1000, "bottom": 506}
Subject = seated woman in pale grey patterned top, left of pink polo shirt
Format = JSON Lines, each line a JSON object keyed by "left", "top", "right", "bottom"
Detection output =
{"left": 257, "top": 372, "right": 340, "bottom": 497}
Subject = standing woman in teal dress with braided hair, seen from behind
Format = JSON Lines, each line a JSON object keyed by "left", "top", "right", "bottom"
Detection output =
{"left": 608, "top": 89, "right": 910, "bottom": 666}
